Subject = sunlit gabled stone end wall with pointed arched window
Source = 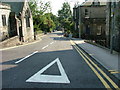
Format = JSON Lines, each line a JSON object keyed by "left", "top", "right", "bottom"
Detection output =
{"left": 21, "top": 2, "right": 34, "bottom": 42}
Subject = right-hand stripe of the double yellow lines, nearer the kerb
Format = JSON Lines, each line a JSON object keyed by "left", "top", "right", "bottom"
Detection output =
{"left": 72, "top": 41, "right": 119, "bottom": 89}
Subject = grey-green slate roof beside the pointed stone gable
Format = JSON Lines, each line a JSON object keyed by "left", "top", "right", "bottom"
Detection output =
{"left": 1, "top": 2, "right": 24, "bottom": 15}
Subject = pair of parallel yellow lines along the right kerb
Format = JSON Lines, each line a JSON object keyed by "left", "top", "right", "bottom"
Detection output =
{"left": 70, "top": 40, "right": 120, "bottom": 90}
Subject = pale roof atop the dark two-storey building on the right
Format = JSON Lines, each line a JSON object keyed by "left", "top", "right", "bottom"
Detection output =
{"left": 81, "top": 0, "right": 107, "bottom": 6}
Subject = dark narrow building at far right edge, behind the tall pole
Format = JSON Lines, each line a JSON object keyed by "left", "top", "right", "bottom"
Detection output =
{"left": 106, "top": 0, "right": 120, "bottom": 51}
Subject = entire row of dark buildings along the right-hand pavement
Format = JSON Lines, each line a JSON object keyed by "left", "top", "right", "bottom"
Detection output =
{"left": 73, "top": 0, "right": 120, "bottom": 51}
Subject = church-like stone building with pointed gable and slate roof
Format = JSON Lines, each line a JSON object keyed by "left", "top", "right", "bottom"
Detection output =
{"left": 0, "top": 0, "right": 34, "bottom": 42}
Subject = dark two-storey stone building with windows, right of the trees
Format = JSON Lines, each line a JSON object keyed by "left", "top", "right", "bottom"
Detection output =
{"left": 73, "top": 0, "right": 106, "bottom": 44}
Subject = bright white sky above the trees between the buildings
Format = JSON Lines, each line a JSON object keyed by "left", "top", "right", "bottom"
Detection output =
{"left": 41, "top": 0, "right": 85, "bottom": 15}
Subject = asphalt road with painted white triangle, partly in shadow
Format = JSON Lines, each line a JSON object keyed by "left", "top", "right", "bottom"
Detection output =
{"left": 1, "top": 31, "right": 119, "bottom": 88}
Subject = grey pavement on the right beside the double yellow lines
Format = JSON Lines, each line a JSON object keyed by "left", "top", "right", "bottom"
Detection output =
{"left": 73, "top": 38, "right": 120, "bottom": 80}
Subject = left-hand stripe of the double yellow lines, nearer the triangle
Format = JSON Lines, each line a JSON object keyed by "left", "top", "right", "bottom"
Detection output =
{"left": 71, "top": 42, "right": 112, "bottom": 90}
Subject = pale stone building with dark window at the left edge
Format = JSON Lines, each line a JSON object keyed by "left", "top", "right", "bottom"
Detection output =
{"left": 0, "top": 3, "right": 11, "bottom": 41}
